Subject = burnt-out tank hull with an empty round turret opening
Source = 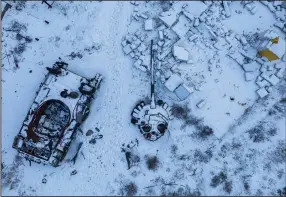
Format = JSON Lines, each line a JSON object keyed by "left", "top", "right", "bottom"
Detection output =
{"left": 13, "top": 62, "right": 102, "bottom": 167}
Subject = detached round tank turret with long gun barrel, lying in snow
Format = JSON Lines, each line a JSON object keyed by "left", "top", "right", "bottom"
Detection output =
{"left": 131, "top": 40, "right": 173, "bottom": 141}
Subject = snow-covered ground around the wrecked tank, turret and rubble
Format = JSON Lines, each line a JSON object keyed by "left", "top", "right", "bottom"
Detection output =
{"left": 2, "top": 1, "right": 286, "bottom": 196}
